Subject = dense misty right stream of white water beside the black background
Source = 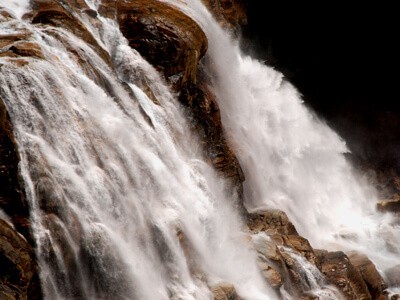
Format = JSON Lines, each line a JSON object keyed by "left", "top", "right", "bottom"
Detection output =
{"left": 178, "top": 1, "right": 400, "bottom": 290}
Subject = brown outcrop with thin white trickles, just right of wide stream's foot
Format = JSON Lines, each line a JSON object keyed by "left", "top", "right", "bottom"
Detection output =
{"left": 247, "top": 210, "right": 319, "bottom": 299}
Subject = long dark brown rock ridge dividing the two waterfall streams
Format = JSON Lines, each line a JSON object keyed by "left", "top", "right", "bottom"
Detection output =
{"left": 99, "top": 0, "right": 244, "bottom": 190}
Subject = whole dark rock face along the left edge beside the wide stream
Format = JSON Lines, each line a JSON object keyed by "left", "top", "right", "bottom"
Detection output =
{"left": 0, "top": 73, "right": 42, "bottom": 299}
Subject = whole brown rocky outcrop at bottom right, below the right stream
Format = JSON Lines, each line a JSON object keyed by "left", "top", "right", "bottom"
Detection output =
{"left": 248, "top": 210, "right": 398, "bottom": 300}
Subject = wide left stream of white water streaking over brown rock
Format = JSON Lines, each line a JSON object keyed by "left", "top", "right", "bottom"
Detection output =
{"left": 0, "top": 3, "right": 276, "bottom": 300}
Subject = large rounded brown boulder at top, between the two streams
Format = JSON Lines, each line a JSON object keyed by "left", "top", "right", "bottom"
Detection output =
{"left": 114, "top": 0, "right": 207, "bottom": 77}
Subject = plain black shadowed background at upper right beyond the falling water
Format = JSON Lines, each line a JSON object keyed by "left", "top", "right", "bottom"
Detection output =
{"left": 239, "top": 0, "right": 400, "bottom": 170}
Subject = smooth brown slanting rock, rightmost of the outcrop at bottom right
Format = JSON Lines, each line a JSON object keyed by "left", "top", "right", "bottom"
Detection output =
{"left": 347, "top": 252, "right": 387, "bottom": 299}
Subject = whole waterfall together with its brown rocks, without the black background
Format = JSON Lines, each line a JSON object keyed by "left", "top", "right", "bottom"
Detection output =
{"left": 0, "top": 0, "right": 400, "bottom": 300}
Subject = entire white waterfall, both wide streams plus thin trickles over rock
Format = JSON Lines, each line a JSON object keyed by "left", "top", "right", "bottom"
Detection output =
{"left": 0, "top": 0, "right": 400, "bottom": 300}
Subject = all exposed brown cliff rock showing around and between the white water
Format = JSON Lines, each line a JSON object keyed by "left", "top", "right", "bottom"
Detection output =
{"left": 0, "top": 0, "right": 396, "bottom": 299}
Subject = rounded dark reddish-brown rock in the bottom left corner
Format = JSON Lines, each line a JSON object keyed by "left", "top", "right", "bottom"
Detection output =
{"left": 0, "top": 219, "right": 41, "bottom": 299}
